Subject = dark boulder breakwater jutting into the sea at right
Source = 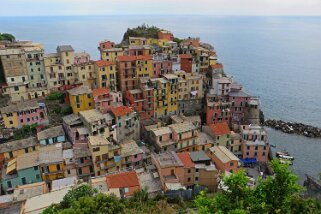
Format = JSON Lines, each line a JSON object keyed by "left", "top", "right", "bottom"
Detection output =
{"left": 263, "top": 120, "right": 321, "bottom": 138}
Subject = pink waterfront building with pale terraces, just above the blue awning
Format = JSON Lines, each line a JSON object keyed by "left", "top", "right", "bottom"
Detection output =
{"left": 241, "top": 125, "right": 270, "bottom": 163}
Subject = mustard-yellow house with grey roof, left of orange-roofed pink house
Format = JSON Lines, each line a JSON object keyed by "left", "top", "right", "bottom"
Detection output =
{"left": 68, "top": 86, "right": 95, "bottom": 114}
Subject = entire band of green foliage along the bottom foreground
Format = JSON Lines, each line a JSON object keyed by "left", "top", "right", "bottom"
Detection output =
{"left": 43, "top": 161, "right": 321, "bottom": 214}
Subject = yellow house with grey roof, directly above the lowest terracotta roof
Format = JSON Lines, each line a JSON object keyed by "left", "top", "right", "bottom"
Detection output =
{"left": 88, "top": 136, "right": 121, "bottom": 176}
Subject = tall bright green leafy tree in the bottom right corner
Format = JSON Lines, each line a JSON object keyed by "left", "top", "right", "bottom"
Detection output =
{"left": 195, "top": 161, "right": 321, "bottom": 214}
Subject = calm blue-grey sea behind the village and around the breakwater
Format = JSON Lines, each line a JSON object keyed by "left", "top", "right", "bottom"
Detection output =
{"left": 0, "top": 15, "right": 321, "bottom": 184}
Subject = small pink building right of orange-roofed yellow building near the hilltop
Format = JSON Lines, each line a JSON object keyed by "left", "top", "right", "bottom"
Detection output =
{"left": 153, "top": 54, "right": 172, "bottom": 78}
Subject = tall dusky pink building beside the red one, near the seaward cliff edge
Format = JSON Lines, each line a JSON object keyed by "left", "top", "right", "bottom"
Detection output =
{"left": 229, "top": 83, "right": 251, "bottom": 124}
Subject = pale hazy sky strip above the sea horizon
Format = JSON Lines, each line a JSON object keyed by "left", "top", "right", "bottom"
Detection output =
{"left": 0, "top": 0, "right": 321, "bottom": 16}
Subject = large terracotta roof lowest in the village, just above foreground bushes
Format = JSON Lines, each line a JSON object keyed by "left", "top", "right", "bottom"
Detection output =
{"left": 106, "top": 171, "right": 139, "bottom": 189}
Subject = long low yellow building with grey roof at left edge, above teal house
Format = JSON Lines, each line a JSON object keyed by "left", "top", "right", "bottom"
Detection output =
{"left": 0, "top": 137, "right": 39, "bottom": 159}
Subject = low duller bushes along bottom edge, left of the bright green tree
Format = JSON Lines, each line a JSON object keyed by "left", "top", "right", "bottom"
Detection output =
{"left": 43, "top": 184, "right": 174, "bottom": 214}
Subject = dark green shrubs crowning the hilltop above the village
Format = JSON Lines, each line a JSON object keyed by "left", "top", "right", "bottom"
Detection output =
{"left": 123, "top": 24, "right": 161, "bottom": 42}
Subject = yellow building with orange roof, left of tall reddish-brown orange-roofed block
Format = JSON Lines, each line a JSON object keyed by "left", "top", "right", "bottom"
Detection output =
{"left": 95, "top": 60, "right": 117, "bottom": 91}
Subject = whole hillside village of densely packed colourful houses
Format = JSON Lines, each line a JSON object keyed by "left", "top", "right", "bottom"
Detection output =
{"left": 0, "top": 30, "right": 271, "bottom": 213}
